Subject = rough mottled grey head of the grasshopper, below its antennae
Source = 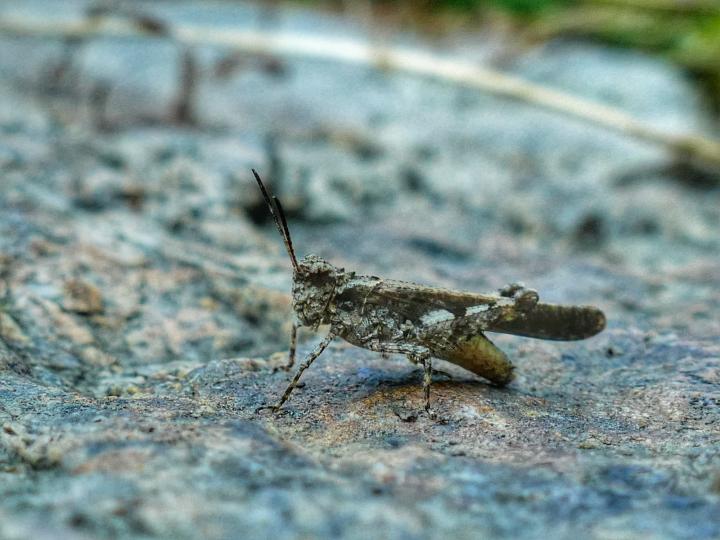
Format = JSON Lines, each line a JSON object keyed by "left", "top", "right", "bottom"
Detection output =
{"left": 293, "top": 255, "right": 345, "bottom": 326}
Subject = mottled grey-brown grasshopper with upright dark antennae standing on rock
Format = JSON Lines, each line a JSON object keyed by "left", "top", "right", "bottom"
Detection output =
{"left": 253, "top": 169, "right": 605, "bottom": 413}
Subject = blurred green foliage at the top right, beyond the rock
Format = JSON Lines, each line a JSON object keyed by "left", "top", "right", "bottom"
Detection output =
{"left": 298, "top": 0, "right": 720, "bottom": 106}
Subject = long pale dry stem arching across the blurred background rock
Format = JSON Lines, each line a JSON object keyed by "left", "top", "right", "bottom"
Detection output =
{"left": 0, "top": 13, "right": 720, "bottom": 167}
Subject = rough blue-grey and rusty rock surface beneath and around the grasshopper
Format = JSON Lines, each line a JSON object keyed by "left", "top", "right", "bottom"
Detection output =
{"left": 0, "top": 1, "right": 720, "bottom": 539}
